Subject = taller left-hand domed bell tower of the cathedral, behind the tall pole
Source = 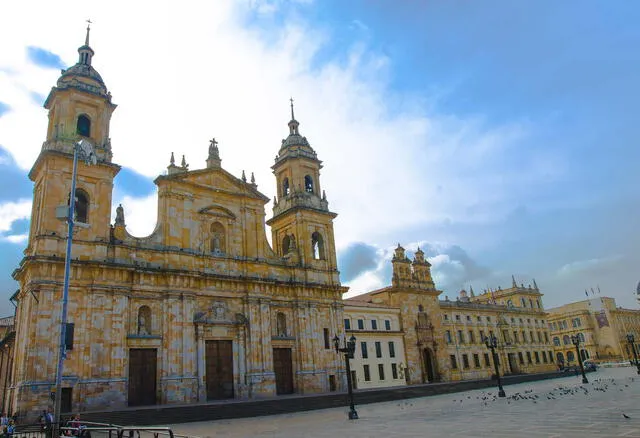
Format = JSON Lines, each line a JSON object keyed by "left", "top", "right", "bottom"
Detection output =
{"left": 25, "top": 26, "right": 120, "bottom": 257}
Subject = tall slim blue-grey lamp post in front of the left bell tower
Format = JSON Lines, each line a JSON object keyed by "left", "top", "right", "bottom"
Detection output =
{"left": 53, "top": 140, "right": 97, "bottom": 436}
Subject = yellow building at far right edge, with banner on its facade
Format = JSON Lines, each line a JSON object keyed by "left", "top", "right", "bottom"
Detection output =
{"left": 548, "top": 296, "right": 640, "bottom": 365}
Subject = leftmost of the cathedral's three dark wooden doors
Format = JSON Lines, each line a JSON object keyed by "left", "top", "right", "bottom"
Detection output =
{"left": 129, "top": 348, "right": 158, "bottom": 406}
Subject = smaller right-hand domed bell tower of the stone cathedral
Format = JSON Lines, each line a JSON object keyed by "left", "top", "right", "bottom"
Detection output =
{"left": 267, "top": 99, "right": 338, "bottom": 283}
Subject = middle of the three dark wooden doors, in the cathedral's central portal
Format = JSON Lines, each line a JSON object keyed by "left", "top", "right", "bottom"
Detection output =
{"left": 205, "top": 341, "right": 233, "bottom": 400}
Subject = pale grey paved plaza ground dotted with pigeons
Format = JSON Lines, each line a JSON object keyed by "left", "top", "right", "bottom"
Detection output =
{"left": 172, "top": 367, "right": 640, "bottom": 438}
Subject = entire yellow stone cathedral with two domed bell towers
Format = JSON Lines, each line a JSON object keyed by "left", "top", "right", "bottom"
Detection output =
{"left": 9, "top": 29, "right": 346, "bottom": 416}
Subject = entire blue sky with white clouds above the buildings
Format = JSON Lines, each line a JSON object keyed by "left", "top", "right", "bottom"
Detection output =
{"left": 0, "top": 0, "right": 640, "bottom": 316}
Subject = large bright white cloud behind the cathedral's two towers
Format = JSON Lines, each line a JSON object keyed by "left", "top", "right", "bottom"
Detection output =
{"left": 0, "top": 0, "right": 556, "bottom": 272}
